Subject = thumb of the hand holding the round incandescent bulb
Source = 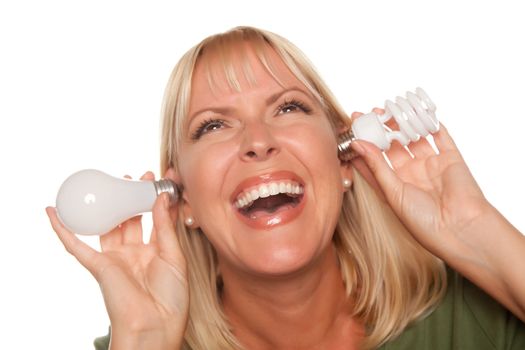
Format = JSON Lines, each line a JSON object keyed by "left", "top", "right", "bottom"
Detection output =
{"left": 153, "top": 193, "right": 184, "bottom": 264}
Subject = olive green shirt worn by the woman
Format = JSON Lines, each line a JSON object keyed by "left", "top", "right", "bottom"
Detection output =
{"left": 95, "top": 270, "right": 525, "bottom": 350}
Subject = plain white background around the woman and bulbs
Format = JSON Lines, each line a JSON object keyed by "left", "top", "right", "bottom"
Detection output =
{"left": 0, "top": 0, "right": 525, "bottom": 349}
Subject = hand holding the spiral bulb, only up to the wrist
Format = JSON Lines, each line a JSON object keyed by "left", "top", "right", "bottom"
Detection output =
{"left": 352, "top": 109, "right": 492, "bottom": 256}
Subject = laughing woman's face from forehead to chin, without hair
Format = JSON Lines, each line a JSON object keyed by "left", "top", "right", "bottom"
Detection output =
{"left": 179, "top": 45, "right": 344, "bottom": 275}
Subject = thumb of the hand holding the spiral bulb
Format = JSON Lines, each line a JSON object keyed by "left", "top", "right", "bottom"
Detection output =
{"left": 351, "top": 141, "right": 403, "bottom": 204}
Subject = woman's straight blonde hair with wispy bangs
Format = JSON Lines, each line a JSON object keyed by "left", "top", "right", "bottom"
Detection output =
{"left": 161, "top": 27, "right": 446, "bottom": 350}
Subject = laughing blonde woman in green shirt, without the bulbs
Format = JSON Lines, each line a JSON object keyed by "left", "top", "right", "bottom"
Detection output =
{"left": 48, "top": 27, "right": 525, "bottom": 349}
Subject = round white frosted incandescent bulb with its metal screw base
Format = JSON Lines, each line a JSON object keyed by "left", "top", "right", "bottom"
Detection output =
{"left": 56, "top": 169, "right": 178, "bottom": 235}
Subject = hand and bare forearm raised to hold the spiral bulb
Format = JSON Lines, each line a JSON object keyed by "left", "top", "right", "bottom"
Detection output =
{"left": 352, "top": 109, "right": 525, "bottom": 321}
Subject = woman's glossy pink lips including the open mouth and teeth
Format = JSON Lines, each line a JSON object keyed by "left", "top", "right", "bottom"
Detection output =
{"left": 231, "top": 171, "right": 306, "bottom": 229}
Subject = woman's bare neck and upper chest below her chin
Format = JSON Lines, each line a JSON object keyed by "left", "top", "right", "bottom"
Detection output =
{"left": 221, "top": 247, "right": 363, "bottom": 349}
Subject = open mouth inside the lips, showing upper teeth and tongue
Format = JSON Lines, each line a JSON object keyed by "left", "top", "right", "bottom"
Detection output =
{"left": 235, "top": 180, "right": 304, "bottom": 219}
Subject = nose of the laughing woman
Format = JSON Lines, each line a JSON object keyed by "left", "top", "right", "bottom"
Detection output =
{"left": 239, "top": 123, "right": 280, "bottom": 161}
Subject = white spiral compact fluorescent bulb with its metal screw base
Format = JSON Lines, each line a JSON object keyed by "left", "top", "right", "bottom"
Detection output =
{"left": 338, "top": 88, "right": 439, "bottom": 161}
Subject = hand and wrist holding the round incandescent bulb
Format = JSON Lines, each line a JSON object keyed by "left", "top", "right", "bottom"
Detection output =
{"left": 46, "top": 173, "right": 189, "bottom": 350}
